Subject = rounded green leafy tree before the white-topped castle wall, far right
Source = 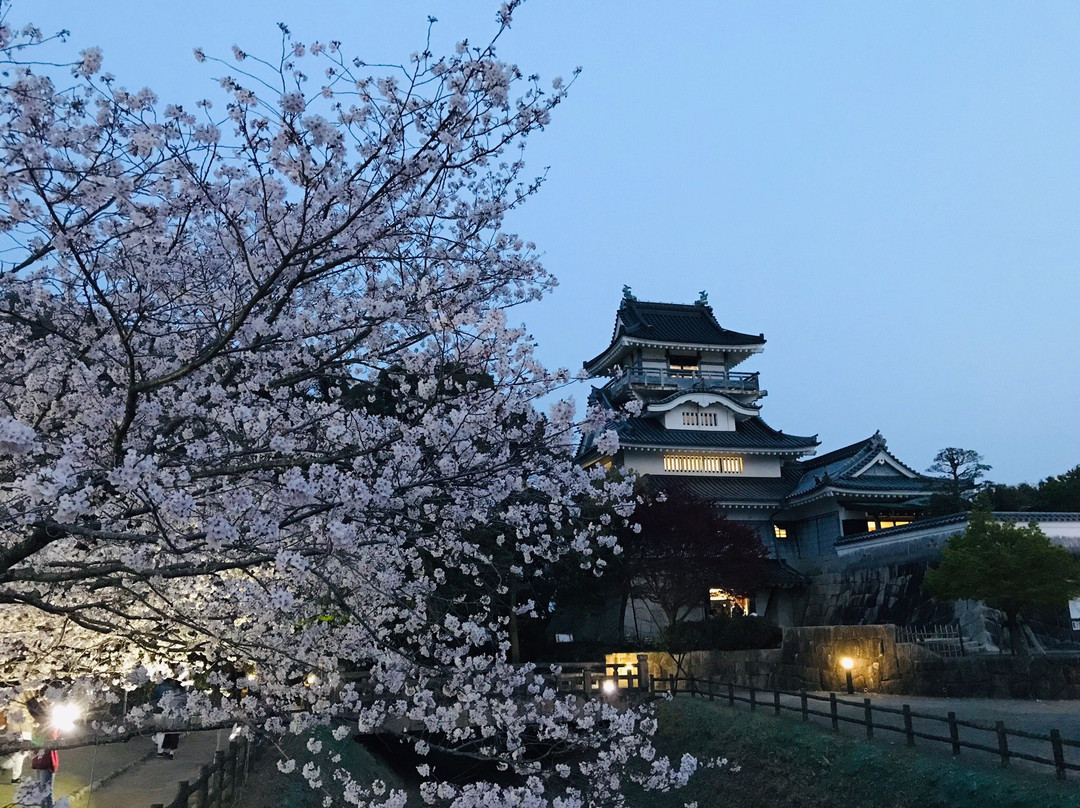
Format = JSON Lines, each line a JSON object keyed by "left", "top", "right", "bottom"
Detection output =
{"left": 926, "top": 511, "right": 1080, "bottom": 655}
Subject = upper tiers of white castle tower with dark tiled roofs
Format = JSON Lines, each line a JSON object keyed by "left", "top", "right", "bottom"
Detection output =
{"left": 580, "top": 291, "right": 819, "bottom": 547}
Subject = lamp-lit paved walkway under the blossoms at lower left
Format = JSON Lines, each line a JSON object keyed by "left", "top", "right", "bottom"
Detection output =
{"left": 0, "top": 731, "right": 229, "bottom": 808}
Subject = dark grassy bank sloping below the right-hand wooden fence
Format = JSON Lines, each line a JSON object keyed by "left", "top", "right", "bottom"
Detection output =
{"left": 633, "top": 699, "right": 1080, "bottom": 808}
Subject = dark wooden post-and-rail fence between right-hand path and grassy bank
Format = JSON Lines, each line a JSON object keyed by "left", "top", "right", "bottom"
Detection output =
{"left": 665, "top": 676, "right": 1080, "bottom": 780}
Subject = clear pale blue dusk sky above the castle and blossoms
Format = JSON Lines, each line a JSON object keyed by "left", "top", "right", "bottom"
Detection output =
{"left": 23, "top": 0, "right": 1080, "bottom": 483}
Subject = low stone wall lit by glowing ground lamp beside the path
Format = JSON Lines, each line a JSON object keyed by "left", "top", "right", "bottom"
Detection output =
{"left": 607, "top": 625, "right": 1080, "bottom": 699}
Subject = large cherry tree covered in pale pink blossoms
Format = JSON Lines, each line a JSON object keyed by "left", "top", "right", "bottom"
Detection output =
{"left": 0, "top": 3, "right": 708, "bottom": 806}
